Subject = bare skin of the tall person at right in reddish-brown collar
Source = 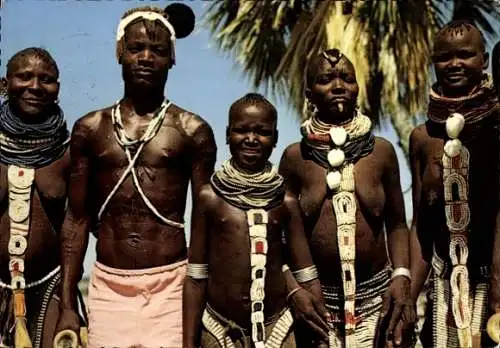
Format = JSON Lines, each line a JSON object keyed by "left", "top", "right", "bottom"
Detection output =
{"left": 410, "top": 29, "right": 500, "bottom": 342}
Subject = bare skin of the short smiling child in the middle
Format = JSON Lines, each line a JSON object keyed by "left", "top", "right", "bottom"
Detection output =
{"left": 183, "top": 105, "right": 327, "bottom": 347}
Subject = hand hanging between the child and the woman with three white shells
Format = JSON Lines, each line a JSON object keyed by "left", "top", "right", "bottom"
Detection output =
{"left": 289, "top": 288, "right": 328, "bottom": 341}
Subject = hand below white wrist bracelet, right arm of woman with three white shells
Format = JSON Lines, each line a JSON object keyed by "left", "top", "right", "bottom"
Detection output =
{"left": 379, "top": 276, "right": 416, "bottom": 348}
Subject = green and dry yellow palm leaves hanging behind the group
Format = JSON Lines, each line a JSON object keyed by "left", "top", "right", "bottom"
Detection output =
{"left": 203, "top": 0, "right": 500, "bottom": 159}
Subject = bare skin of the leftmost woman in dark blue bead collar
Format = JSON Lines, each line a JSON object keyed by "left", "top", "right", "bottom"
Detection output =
{"left": 0, "top": 55, "right": 70, "bottom": 346}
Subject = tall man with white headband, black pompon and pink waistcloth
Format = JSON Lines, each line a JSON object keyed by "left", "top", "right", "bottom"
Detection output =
{"left": 53, "top": 4, "right": 216, "bottom": 348}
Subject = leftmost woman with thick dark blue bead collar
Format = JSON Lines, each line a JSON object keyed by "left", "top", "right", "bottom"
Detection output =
{"left": 0, "top": 47, "right": 86, "bottom": 348}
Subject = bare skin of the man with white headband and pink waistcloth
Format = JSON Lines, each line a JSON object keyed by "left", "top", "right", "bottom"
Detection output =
{"left": 58, "top": 22, "right": 216, "bottom": 330}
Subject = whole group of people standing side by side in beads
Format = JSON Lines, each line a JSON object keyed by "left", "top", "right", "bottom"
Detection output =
{"left": 0, "top": 3, "right": 500, "bottom": 348}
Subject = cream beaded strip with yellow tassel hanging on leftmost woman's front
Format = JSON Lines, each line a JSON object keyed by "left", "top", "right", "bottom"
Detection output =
{"left": 7, "top": 165, "right": 35, "bottom": 347}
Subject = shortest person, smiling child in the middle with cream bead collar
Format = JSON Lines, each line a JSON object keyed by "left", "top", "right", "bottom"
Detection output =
{"left": 184, "top": 93, "right": 327, "bottom": 348}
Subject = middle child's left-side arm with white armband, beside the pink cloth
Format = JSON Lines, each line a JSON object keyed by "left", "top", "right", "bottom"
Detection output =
{"left": 182, "top": 185, "right": 212, "bottom": 348}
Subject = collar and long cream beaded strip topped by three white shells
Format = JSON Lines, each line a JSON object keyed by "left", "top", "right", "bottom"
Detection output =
{"left": 301, "top": 111, "right": 375, "bottom": 348}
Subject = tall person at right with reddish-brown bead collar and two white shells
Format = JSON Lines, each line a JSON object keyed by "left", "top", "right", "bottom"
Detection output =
{"left": 410, "top": 21, "right": 499, "bottom": 348}
